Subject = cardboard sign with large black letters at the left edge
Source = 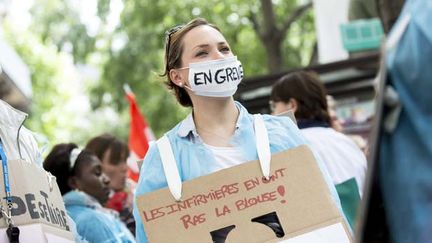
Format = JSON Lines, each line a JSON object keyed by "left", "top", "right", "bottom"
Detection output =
{"left": 0, "top": 160, "right": 72, "bottom": 237}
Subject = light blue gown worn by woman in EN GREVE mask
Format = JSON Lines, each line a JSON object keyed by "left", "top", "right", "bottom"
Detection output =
{"left": 133, "top": 102, "right": 342, "bottom": 243}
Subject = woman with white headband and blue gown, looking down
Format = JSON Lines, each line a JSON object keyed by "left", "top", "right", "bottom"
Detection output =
{"left": 43, "top": 143, "right": 135, "bottom": 243}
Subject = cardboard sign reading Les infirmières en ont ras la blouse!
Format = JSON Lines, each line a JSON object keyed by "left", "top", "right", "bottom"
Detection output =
{"left": 137, "top": 145, "right": 351, "bottom": 243}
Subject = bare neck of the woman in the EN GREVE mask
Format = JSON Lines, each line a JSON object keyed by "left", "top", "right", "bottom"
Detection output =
{"left": 193, "top": 98, "right": 239, "bottom": 147}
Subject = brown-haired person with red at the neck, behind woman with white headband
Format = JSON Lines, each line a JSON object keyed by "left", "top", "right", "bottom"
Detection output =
{"left": 85, "top": 134, "right": 136, "bottom": 234}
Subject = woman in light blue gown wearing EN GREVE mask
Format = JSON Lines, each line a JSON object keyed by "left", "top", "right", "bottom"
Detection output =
{"left": 134, "top": 18, "right": 346, "bottom": 242}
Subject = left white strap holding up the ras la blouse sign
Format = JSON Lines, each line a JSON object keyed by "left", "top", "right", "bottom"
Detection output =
{"left": 156, "top": 135, "right": 182, "bottom": 201}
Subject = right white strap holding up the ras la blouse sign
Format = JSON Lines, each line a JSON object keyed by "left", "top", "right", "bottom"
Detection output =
{"left": 254, "top": 114, "right": 271, "bottom": 180}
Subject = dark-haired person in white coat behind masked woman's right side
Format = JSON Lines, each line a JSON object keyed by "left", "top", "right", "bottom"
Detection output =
{"left": 270, "top": 71, "right": 367, "bottom": 226}
